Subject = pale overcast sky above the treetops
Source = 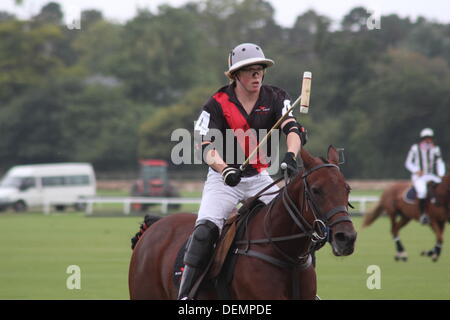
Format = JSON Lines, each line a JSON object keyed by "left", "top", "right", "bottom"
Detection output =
{"left": 0, "top": 0, "right": 450, "bottom": 27}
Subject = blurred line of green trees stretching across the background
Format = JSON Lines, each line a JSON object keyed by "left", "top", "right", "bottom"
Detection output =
{"left": 0, "top": 0, "right": 450, "bottom": 178}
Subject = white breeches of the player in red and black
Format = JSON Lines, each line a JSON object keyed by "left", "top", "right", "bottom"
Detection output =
{"left": 197, "top": 168, "right": 279, "bottom": 230}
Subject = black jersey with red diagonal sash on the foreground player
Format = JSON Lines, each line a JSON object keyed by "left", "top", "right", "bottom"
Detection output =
{"left": 195, "top": 84, "right": 302, "bottom": 176}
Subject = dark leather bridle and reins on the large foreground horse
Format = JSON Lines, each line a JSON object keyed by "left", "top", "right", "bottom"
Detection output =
{"left": 234, "top": 163, "right": 351, "bottom": 297}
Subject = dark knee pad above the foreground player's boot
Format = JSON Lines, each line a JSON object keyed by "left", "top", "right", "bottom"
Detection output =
{"left": 183, "top": 220, "right": 219, "bottom": 268}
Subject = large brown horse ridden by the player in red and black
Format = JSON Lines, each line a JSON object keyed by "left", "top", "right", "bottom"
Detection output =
{"left": 129, "top": 146, "right": 356, "bottom": 299}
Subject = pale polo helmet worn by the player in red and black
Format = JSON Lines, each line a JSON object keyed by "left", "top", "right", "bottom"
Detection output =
{"left": 225, "top": 43, "right": 275, "bottom": 79}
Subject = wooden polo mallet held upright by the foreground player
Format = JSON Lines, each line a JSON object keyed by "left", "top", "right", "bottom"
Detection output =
{"left": 239, "top": 71, "right": 312, "bottom": 172}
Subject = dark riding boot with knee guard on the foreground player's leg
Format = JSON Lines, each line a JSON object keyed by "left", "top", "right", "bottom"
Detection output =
{"left": 178, "top": 220, "right": 219, "bottom": 300}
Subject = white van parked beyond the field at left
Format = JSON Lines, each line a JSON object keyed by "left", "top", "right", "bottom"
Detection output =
{"left": 0, "top": 163, "right": 96, "bottom": 211}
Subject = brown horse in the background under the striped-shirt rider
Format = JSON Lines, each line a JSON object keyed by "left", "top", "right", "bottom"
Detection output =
{"left": 362, "top": 174, "right": 450, "bottom": 261}
